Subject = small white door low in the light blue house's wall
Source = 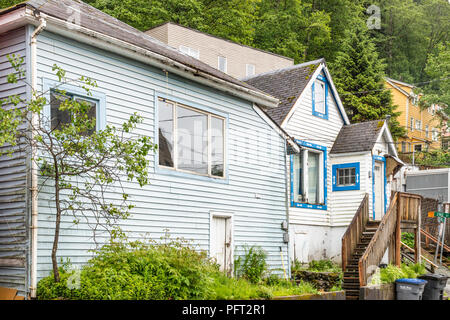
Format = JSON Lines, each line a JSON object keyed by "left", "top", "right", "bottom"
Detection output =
{"left": 211, "top": 217, "right": 232, "bottom": 273}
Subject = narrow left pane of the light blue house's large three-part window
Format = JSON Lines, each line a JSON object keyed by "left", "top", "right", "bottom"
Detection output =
{"left": 158, "top": 101, "right": 174, "bottom": 168}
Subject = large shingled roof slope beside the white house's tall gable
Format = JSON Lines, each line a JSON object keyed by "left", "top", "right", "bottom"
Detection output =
{"left": 243, "top": 59, "right": 325, "bottom": 125}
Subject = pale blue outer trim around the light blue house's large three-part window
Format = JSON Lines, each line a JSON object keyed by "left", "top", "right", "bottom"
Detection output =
{"left": 154, "top": 90, "right": 230, "bottom": 184}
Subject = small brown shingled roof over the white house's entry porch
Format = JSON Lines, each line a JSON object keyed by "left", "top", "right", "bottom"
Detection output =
{"left": 330, "top": 120, "right": 385, "bottom": 154}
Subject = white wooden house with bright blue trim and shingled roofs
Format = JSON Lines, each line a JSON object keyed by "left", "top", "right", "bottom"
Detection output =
{"left": 244, "top": 59, "right": 397, "bottom": 262}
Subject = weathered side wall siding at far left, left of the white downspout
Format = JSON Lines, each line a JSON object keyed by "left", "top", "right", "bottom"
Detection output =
{"left": 0, "top": 27, "right": 29, "bottom": 295}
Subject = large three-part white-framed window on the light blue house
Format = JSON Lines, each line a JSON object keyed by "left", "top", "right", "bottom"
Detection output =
{"left": 158, "top": 99, "right": 225, "bottom": 178}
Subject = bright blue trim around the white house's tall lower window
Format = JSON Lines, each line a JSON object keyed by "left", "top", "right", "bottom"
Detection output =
{"left": 290, "top": 140, "right": 328, "bottom": 210}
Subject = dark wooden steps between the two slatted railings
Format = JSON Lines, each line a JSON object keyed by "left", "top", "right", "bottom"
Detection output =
{"left": 342, "top": 221, "right": 380, "bottom": 300}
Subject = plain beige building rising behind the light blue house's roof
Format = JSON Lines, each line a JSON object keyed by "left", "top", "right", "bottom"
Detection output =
{"left": 146, "top": 22, "right": 294, "bottom": 79}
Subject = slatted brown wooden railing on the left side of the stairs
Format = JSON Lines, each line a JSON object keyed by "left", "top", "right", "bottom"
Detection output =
{"left": 342, "top": 193, "right": 369, "bottom": 271}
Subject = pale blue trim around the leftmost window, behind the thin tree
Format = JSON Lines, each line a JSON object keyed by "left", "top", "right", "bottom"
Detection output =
{"left": 42, "top": 78, "right": 106, "bottom": 130}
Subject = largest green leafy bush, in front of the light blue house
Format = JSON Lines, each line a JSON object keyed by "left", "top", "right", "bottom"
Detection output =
{"left": 37, "top": 241, "right": 218, "bottom": 300}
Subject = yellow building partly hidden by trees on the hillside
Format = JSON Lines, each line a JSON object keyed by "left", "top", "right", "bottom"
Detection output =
{"left": 385, "top": 78, "right": 441, "bottom": 153}
